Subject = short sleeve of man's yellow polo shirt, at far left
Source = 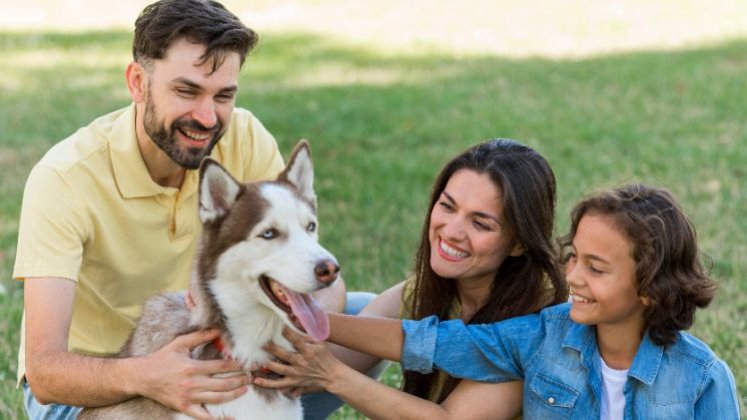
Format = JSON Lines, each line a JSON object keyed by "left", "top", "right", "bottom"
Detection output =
{"left": 13, "top": 166, "right": 89, "bottom": 281}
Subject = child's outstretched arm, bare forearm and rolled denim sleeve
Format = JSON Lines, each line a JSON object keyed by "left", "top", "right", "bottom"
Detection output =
{"left": 328, "top": 308, "right": 536, "bottom": 383}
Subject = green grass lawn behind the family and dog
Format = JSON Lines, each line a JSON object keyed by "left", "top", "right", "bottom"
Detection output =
{"left": 0, "top": 21, "right": 747, "bottom": 418}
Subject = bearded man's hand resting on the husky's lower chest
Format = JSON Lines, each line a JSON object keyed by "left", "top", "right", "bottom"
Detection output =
{"left": 135, "top": 330, "right": 251, "bottom": 419}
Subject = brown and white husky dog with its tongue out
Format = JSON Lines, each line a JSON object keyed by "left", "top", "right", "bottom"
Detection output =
{"left": 79, "top": 140, "right": 340, "bottom": 420}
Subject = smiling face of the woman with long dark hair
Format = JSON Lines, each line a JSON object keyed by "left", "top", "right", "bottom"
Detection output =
{"left": 428, "top": 169, "right": 521, "bottom": 282}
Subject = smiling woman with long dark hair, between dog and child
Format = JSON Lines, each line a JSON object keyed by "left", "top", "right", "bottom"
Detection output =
{"left": 255, "top": 139, "right": 567, "bottom": 418}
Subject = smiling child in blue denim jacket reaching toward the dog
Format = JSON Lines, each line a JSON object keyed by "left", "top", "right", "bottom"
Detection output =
{"left": 331, "top": 184, "right": 739, "bottom": 419}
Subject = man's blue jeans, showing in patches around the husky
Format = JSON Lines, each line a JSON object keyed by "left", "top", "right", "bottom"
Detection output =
{"left": 23, "top": 292, "right": 388, "bottom": 420}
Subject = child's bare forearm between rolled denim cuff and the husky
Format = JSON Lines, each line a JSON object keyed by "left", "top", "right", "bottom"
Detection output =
{"left": 327, "top": 314, "right": 404, "bottom": 362}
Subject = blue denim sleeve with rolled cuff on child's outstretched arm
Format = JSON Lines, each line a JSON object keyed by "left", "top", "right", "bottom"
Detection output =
{"left": 401, "top": 315, "right": 544, "bottom": 382}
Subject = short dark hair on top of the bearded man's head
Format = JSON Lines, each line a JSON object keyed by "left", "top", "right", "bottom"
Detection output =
{"left": 132, "top": 0, "right": 258, "bottom": 71}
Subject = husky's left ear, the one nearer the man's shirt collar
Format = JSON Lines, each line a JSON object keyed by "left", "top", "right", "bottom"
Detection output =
{"left": 199, "top": 158, "right": 241, "bottom": 224}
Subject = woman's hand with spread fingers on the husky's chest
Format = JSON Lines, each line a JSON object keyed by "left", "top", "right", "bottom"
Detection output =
{"left": 252, "top": 327, "right": 347, "bottom": 396}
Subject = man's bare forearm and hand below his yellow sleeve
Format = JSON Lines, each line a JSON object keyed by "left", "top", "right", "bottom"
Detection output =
{"left": 24, "top": 277, "right": 249, "bottom": 418}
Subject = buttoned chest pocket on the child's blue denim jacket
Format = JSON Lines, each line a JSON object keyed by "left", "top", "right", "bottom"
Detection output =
{"left": 524, "top": 373, "right": 579, "bottom": 419}
